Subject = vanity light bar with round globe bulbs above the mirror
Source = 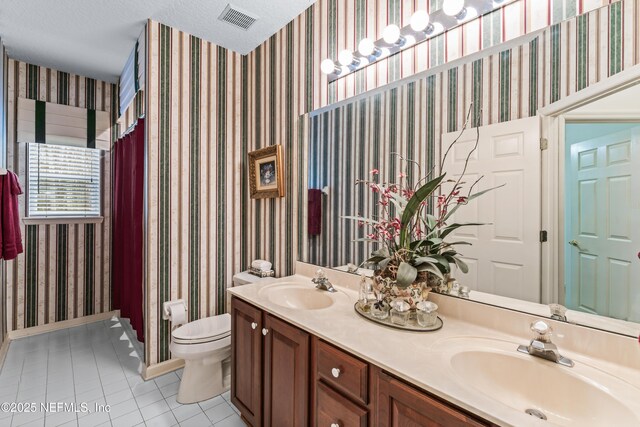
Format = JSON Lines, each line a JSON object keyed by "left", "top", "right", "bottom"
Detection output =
{"left": 322, "top": 0, "right": 515, "bottom": 82}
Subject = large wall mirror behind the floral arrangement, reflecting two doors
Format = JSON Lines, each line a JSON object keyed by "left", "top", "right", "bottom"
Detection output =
{"left": 300, "top": 30, "right": 640, "bottom": 336}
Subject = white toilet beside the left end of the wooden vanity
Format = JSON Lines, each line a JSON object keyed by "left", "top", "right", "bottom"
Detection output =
{"left": 163, "top": 272, "right": 272, "bottom": 403}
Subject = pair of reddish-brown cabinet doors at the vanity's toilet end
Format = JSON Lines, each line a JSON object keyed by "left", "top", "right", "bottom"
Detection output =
{"left": 231, "top": 297, "right": 309, "bottom": 427}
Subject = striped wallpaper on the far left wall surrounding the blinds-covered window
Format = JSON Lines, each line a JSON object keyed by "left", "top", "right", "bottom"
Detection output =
{"left": 6, "top": 59, "right": 117, "bottom": 331}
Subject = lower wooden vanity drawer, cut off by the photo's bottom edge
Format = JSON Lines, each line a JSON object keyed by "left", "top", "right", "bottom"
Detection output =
{"left": 315, "top": 382, "right": 368, "bottom": 427}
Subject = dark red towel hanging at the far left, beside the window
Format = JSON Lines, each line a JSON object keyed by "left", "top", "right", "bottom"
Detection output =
{"left": 0, "top": 171, "right": 23, "bottom": 261}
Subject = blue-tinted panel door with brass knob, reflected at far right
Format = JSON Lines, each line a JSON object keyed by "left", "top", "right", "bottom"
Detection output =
{"left": 565, "top": 127, "right": 640, "bottom": 322}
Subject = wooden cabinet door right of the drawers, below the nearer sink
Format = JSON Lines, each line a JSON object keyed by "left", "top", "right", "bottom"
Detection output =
{"left": 376, "top": 370, "right": 489, "bottom": 427}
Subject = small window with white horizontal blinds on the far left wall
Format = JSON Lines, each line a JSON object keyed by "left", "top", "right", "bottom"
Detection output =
{"left": 27, "top": 143, "right": 102, "bottom": 218}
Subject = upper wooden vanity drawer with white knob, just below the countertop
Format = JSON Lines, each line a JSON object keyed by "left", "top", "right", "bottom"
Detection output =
{"left": 316, "top": 340, "right": 369, "bottom": 405}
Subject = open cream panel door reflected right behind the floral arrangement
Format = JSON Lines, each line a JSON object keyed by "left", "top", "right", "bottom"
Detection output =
{"left": 442, "top": 117, "right": 541, "bottom": 302}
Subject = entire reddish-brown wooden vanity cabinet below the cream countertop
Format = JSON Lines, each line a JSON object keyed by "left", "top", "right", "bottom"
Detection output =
{"left": 231, "top": 297, "right": 492, "bottom": 427}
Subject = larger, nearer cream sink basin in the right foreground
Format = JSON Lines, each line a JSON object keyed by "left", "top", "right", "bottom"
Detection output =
{"left": 438, "top": 338, "right": 640, "bottom": 427}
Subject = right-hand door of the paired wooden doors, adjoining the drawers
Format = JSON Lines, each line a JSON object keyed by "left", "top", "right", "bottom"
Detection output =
{"left": 264, "top": 314, "right": 309, "bottom": 427}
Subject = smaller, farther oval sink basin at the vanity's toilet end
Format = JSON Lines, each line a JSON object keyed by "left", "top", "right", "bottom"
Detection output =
{"left": 259, "top": 282, "right": 334, "bottom": 310}
